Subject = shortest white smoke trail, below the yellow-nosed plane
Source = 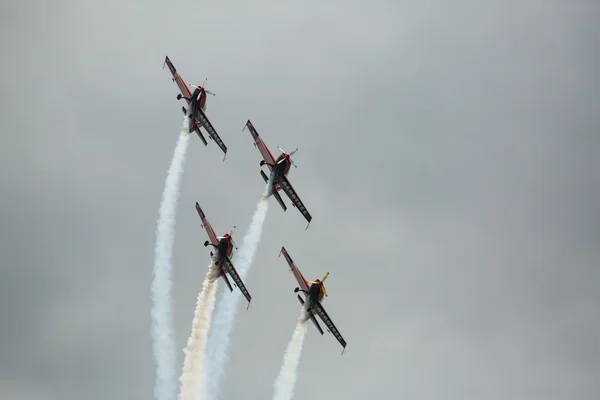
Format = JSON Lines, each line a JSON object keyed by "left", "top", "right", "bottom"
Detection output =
{"left": 273, "top": 308, "right": 308, "bottom": 400}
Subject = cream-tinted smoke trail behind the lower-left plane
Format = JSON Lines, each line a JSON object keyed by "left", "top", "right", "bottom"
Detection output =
{"left": 179, "top": 262, "right": 219, "bottom": 400}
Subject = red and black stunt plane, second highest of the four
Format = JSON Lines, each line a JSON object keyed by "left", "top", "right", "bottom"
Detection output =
{"left": 242, "top": 120, "right": 312, "bottom": 229}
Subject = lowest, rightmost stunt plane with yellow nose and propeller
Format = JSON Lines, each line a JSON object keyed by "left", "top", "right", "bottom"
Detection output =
{"left": 278, "top": 246, "right": 346, "bottom": 354}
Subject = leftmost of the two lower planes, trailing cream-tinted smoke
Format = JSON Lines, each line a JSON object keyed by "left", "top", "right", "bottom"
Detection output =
{"left": 196, "top": 202, "right": 252, "bottom": 309}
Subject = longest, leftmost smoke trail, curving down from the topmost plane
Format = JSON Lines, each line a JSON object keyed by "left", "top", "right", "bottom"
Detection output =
{"left": 151, "top": 116, "right": 190, "bottom": 400}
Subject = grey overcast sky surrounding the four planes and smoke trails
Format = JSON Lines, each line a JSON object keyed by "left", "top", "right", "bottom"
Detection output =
{"left": 0, "top": 0, "right": 600, "bottom": 400}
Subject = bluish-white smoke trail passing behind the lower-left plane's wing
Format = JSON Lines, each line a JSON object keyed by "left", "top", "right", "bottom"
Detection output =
{"left": 202, "top": 186, "right": 269, "bottom": 400}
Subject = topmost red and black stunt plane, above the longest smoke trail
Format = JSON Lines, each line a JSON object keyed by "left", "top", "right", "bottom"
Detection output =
{"left": 163, "top": 56, "right": 227, "bottom": 161}
